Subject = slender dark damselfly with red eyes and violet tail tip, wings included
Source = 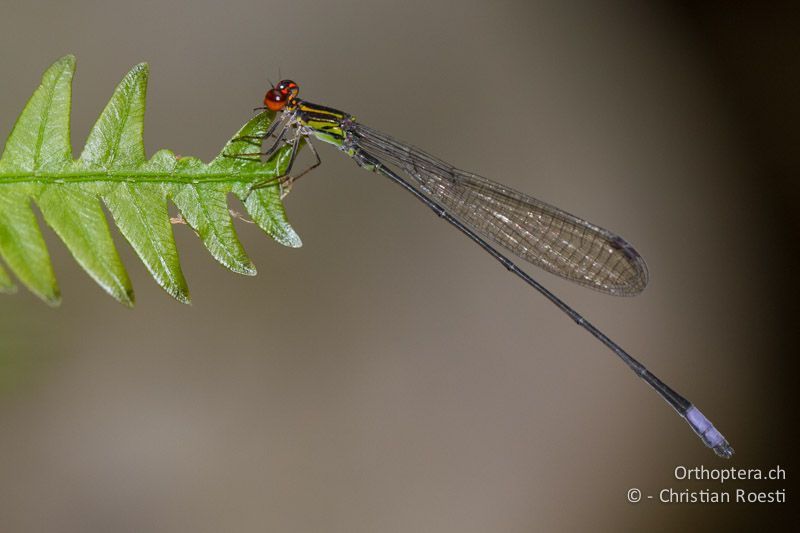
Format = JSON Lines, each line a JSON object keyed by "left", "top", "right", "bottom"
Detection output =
{"left": 236, "top": 80, "right": 733, "bottom": 458}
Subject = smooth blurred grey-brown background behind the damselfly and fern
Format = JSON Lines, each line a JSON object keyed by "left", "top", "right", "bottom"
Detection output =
{"left": 0, "top": 0, "right": 800, "bottom": 533}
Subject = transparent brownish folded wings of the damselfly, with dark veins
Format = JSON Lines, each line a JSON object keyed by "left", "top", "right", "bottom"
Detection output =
{"left": 351, "top": 124, "right": 648, "bottom": 296}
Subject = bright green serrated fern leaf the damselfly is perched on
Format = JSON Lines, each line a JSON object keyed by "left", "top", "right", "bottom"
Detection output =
{"left": 0, "top": 56, "right": 301, "bottom": 306}
